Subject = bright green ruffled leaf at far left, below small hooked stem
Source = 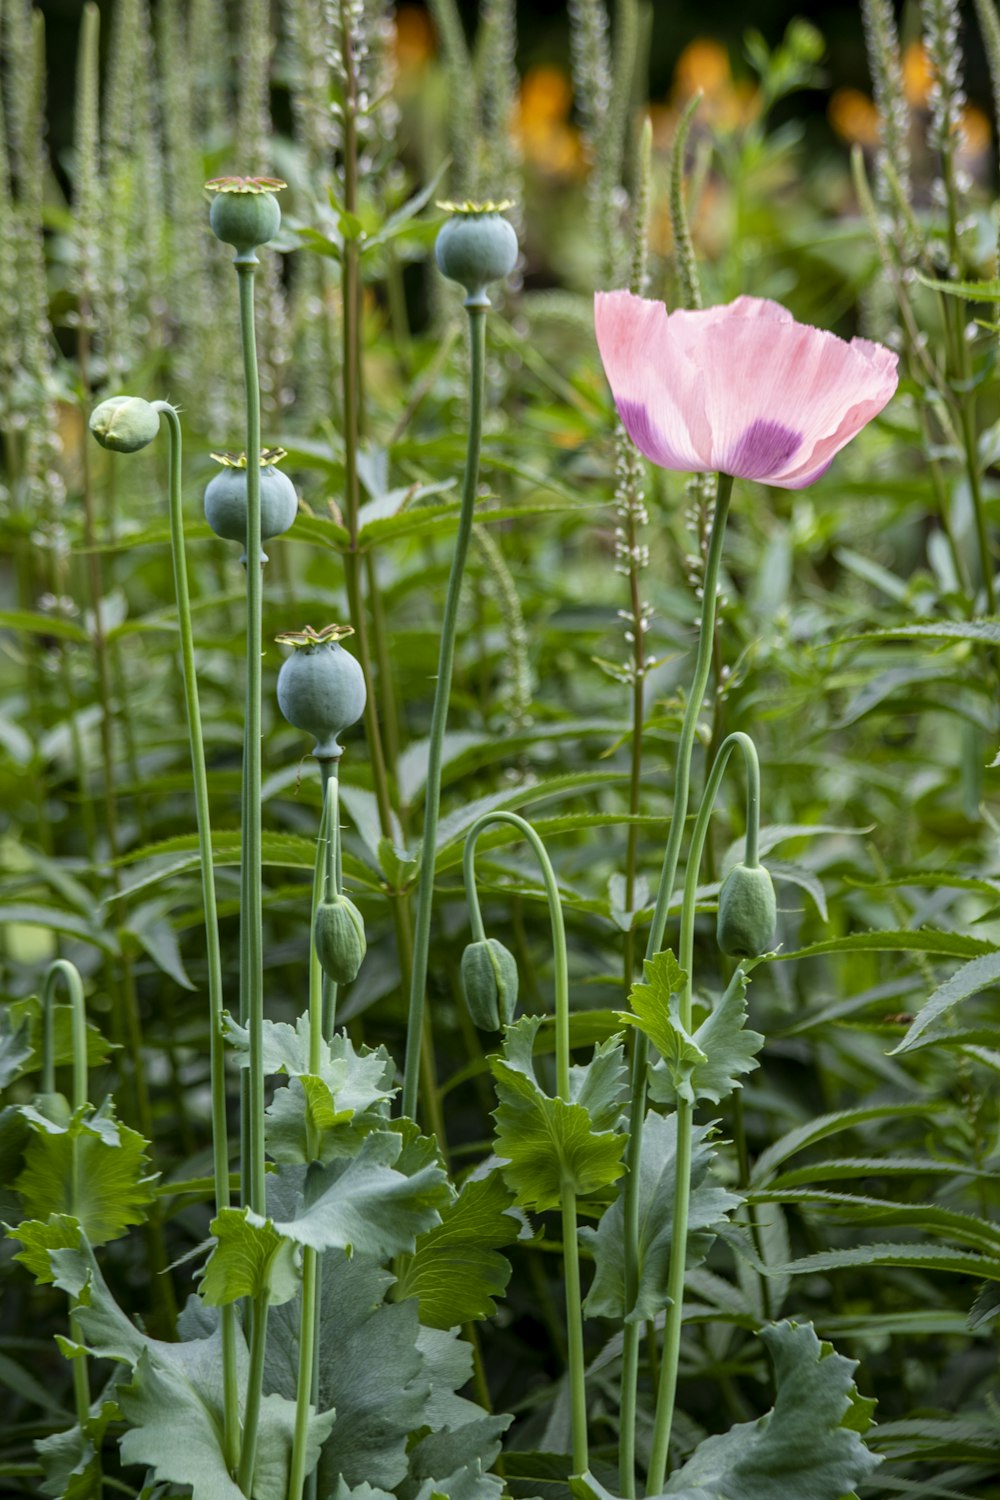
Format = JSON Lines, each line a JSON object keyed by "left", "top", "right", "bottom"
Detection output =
{"left": 13, "top": 1095, "right": 156, "bottom": 1245}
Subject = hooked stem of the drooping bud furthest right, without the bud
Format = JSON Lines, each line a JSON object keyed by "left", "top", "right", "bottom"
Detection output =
{"left": 648, "top": 732, "right": 760, "bottom": 1496}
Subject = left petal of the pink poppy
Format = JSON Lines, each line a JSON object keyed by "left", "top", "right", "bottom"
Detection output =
{"left": 594, "top": 291, "right": 711, "bottom": 473}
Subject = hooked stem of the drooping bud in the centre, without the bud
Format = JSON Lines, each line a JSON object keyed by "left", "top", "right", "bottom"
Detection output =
{"left": 462, "top": 812, "right": 589, "bottom": 1475}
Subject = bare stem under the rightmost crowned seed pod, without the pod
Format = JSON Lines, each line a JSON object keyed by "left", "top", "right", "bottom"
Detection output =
{"left": 402, "top": 306, "right": 487, "bottom": 1119}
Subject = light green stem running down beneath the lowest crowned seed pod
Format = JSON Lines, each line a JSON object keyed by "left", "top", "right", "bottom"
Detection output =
{"left": 288, "top": 759, "right": 339, "bottom": 1500}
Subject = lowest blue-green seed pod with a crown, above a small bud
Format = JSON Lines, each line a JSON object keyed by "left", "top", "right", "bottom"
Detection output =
{"left": 277, "top": 626, "right": 367, "bottom": 761}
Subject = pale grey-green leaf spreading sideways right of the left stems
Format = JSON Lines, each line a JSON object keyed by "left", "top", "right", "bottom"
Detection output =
{"left": 263, "top": 1130, "right": 451, "bottom": 1259}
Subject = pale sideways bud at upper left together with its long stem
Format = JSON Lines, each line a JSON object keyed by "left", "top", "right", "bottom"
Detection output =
{"left": 90, "top": 396, "right": 240, "bottom": 1467}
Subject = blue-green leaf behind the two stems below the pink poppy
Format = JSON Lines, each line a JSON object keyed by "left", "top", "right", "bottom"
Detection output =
{"left": 580, "top": 1110, "right": 741, "bottom": 1323}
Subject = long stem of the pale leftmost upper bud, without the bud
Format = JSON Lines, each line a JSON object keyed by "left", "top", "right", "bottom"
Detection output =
{"left": 153, "top": 401, "right": 240, "bottom": 1472}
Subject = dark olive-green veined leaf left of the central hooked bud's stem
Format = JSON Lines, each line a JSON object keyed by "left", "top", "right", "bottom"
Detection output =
{"left": 393, "top": 1172, "right": 519, "bottom": 1329}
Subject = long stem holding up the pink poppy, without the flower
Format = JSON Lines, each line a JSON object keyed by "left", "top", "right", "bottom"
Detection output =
{"left": 619, "top": 474, "right": 733, "bottom": 1500}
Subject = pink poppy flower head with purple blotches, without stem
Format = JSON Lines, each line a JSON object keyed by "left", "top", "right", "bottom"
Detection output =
{"left": 594, "top": 291, "right": 898, "bottom": 489}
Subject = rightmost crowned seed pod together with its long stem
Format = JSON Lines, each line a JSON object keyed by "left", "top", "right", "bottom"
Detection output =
{"left": 402, "top": 204, "right": 517, "bottom": 1119}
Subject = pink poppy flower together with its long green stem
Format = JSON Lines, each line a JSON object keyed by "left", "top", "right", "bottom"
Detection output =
{"left": 594, "top": 291, "right": 898, "bottom": 1497}
